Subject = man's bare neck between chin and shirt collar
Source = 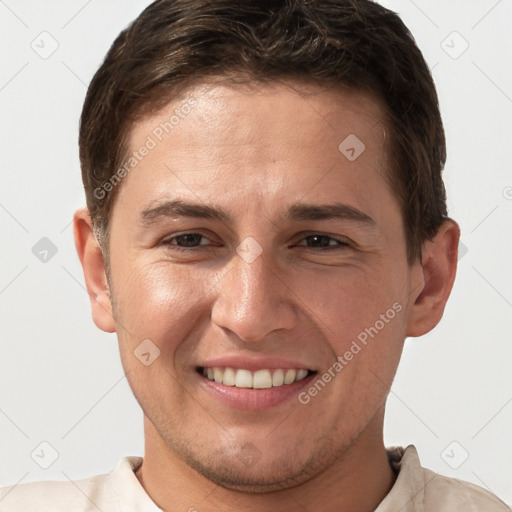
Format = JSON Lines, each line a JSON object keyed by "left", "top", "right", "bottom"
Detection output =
{"left": 135, "top": 411, "right": 396, "bottom": 512}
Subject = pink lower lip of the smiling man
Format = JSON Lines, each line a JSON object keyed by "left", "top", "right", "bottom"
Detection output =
{"left": 196, "top": 372, "right": 316, "bottom": 411}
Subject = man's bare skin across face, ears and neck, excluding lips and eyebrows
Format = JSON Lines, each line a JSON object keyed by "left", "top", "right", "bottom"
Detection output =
{"left": 74, "top": 81, "right": 459, "bottom": 512}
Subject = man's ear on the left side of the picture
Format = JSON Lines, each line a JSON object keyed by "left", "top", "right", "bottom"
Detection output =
{"left": 73, "top": 208, "right": 116, "bottom": 332}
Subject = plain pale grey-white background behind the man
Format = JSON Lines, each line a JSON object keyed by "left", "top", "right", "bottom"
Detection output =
{"left": 0, "top": 0, "right": 512, "bottom": 503}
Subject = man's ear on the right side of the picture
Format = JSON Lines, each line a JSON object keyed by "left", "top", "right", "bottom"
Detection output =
{"left": 407, "top": 219, "right": 460, "bottom": 336}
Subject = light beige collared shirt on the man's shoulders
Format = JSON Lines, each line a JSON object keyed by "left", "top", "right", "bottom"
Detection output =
{"left": 0, "top": 445, "right": 511, "bottom": 512}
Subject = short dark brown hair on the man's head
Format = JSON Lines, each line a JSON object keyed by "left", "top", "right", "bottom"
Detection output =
{"left": 79, "top": 0, "right": 447, "bottom": 264}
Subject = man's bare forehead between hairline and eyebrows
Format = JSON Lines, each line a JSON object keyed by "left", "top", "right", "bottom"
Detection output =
{"left": 116, "top": 82, "right": 394, "bottom": 222}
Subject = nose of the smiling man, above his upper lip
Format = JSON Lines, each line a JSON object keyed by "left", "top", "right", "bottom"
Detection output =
{"left": 212, "top": 245, "right": 296, "bottom": 342}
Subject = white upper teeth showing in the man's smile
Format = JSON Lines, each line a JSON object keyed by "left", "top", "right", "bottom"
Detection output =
{"left": 203, "top": 367, "right": 308, "bottom": 389}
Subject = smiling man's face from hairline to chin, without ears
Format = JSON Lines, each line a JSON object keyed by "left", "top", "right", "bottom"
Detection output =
{"left": 109, "top": 84, "right": 415, "bottom": 490}
